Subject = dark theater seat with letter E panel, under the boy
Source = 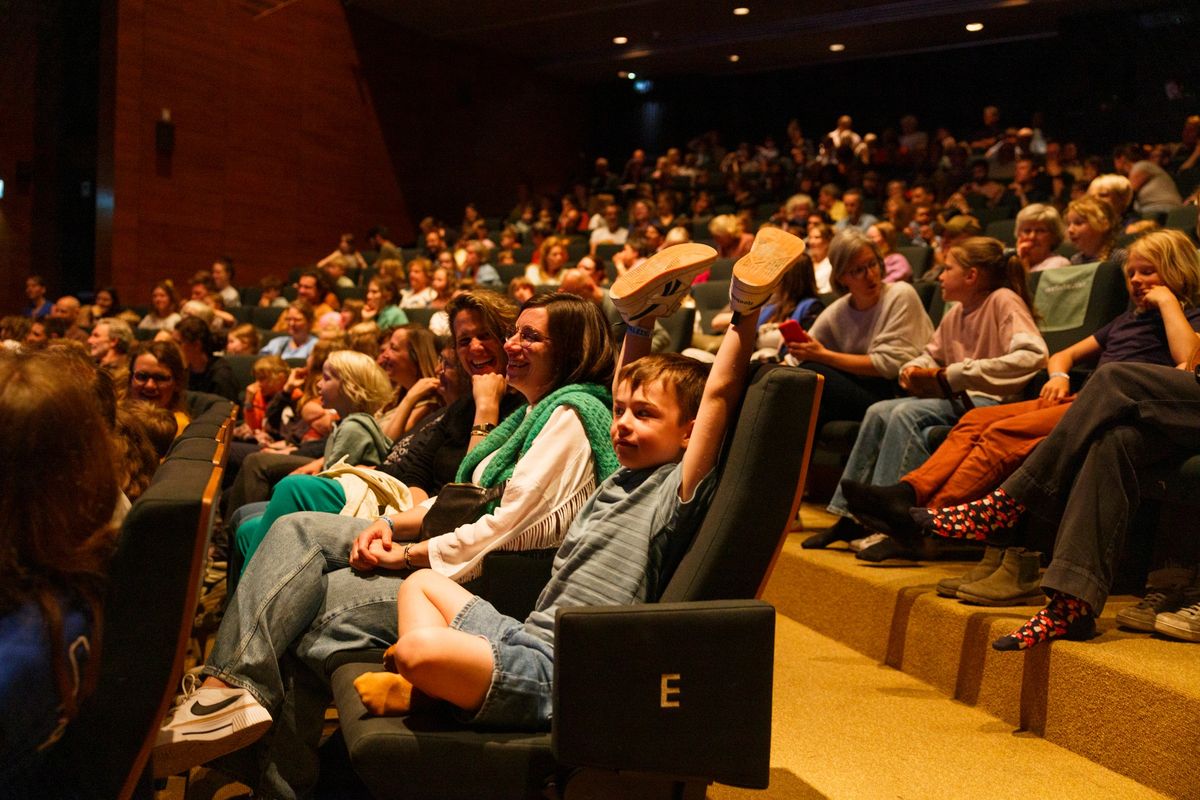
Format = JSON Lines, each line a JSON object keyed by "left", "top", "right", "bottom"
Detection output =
{"left": 329, "top": 366, "right": 822, "bottom": 800}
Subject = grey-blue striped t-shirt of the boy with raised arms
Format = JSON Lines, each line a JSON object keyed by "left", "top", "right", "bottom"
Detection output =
{"left": 524, "top": 463, "right": 716, "bottom": 644}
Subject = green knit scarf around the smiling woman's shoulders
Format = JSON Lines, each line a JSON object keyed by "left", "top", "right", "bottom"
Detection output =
{"left": 455, "top": 384, "right": 619, "bottom": 488}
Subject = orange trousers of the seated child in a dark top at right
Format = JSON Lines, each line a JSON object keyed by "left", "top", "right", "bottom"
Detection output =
{"left": 900, "top": 397, "right": 1074, "bottom": 509}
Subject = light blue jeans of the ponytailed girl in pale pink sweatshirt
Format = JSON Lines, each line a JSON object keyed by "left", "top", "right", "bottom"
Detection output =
{"left": 828, "top": 397, "right": 996, "bottom": 517}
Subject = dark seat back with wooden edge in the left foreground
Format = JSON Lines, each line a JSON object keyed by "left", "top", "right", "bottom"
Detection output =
{"left": 42, "top": 392, "right": 235, "bottom": 800}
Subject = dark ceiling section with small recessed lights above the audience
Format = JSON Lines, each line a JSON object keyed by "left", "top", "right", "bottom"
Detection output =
{"left": 347, "top": 0, "right": 1146, "bottom": 84}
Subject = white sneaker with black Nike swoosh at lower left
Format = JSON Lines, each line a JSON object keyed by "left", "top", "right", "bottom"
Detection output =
{"left": 152, "top": 674, "right": 271, "bottom": 776}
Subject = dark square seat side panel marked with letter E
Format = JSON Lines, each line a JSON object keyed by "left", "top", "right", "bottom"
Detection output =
{"left": 552, "top": 600, "right": 775, "bottom": 789}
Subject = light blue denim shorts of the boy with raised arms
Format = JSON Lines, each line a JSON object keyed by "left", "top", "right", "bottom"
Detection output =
{"left": 450, "top": 597, "right": 554, "bottom": 730}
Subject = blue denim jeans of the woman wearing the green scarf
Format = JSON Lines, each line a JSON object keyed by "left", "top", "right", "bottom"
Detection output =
{"left": 204, "top": 512, "right": 403, "bottom": 798}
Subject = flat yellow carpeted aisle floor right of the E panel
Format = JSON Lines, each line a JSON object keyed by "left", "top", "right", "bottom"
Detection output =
{"left": 706, "top": 615, "right": 1166, "bottom": 800}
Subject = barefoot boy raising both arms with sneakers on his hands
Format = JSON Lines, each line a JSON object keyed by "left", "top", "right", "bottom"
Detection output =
{"left": 355, "top": 229, "right": 804, "bottom": 728}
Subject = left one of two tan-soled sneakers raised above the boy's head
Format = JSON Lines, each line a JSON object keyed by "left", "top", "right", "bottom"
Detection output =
{"left": 608, "top": 242, "right": 716, "bottom": 327}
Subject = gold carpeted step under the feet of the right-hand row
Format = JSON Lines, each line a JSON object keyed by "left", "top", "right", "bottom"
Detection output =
{"left": 764, "top": 525, "right": 1200, "bottom": 796}
